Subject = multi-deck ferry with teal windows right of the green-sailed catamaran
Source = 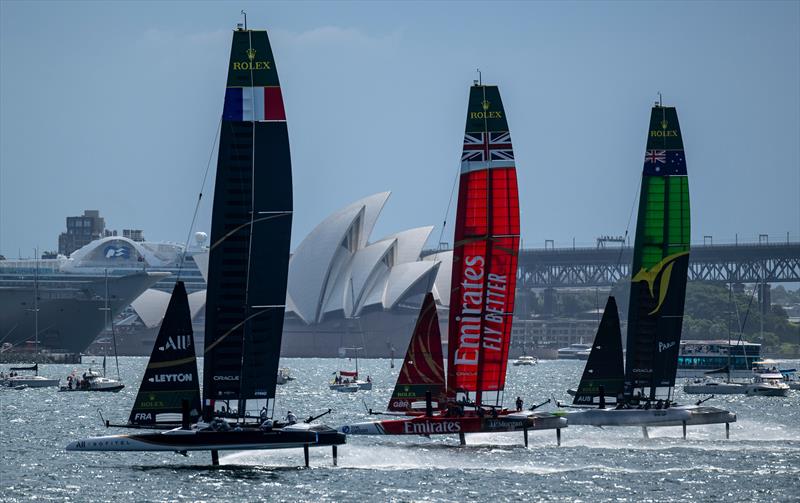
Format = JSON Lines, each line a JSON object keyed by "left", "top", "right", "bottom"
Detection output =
{"left": 678, "top": 340, "right": 761, "bottom": 379}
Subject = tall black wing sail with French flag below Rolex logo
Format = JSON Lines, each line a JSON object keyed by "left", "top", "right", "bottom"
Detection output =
{"left": 203, "top": 30, "right": 292, "bottom": 415}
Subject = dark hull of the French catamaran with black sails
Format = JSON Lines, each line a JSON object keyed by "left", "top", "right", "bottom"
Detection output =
{"left": 67, "top": 426, "right": 345, "bottom": 451}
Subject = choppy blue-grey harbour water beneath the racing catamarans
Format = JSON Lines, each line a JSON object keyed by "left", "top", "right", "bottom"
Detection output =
{"left": 0, "top": 358, "right": 800, "bottom": 503}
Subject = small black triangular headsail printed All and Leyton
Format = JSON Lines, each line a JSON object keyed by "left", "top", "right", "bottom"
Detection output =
{"left": 128, "top": 281, "right": 200, "bottom": 425}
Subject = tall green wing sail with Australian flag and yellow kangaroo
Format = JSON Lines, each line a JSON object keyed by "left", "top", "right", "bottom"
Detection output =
{"left": 625, "top": 104, "right": 690, "bottom": 399}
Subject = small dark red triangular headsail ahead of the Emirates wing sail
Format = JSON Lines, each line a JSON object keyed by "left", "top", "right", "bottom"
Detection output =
{"left": 388, "top": 292, "right": 444, "bottom": 412}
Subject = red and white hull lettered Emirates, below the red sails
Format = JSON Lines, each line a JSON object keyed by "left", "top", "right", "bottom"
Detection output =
{"left": 338, "top": 412, "right": 567, "bottom": 435}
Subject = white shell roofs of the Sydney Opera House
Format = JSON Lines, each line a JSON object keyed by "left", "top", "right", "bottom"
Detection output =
{"left": 286, "top": 192, "right": 440, "bottom": 324}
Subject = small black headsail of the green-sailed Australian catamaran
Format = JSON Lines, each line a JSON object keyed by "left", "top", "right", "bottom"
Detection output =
{"left": 572, "top": 296, "right": 625, "bottom": 405}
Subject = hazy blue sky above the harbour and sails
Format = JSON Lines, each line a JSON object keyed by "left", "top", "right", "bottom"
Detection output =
{"left": 0, "top": 0, "right": 800, "bottom": 258}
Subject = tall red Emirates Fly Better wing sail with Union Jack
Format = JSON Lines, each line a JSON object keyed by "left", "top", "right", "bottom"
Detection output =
{"left": 447, "top": 85, "right": 519, "bottom": 405}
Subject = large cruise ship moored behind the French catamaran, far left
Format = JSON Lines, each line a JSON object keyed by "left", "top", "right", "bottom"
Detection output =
{"left": 0, "top": 236, "right": 205, "bottom": 353}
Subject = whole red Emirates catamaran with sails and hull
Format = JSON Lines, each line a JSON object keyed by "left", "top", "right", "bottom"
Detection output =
{"left": 339, "top": 83, "right": 567, "bottom": 445}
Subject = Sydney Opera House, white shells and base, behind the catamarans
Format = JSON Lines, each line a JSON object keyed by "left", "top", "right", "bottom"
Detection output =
{"left": 283, "top": 192, "right": 452, "bottom": 357}
